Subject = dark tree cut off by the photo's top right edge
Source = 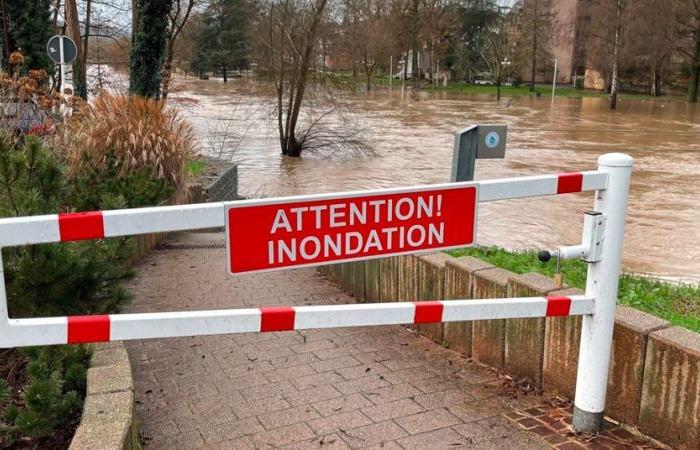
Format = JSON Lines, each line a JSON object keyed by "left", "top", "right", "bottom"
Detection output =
{"left": 674, "top": 0, "right": 700, "bottom": 103}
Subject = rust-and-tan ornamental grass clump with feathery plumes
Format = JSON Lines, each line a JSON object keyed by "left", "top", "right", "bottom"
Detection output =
{"left": 67, "top": 93, "right": 195, "bottom": 196}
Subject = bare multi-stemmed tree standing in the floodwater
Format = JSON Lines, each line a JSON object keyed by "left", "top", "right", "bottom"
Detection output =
{"left": 256, "top": 0, "right": 328, "bottom": 157}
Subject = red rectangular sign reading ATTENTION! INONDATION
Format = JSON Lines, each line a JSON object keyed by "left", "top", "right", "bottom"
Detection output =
{"left": 226, "top": 183, "right": 478, "bottom": 274}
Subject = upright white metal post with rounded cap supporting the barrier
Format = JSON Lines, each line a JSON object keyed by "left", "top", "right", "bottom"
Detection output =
{"left": 572, "top": 153, "right": 632, "bottom": 433}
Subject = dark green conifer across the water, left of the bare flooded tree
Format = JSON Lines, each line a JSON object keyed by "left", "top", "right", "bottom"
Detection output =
{"left": 194, "top": 0, "right": 252, "bottom": 83}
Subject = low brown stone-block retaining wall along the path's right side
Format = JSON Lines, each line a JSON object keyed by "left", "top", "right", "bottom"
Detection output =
{"left": 320, "top": 253, "right": 700, "bottom": 449}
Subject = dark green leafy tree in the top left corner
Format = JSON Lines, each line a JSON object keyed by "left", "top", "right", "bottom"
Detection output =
{"left": 3, "top": 0, "right": 53, "bottom": 73}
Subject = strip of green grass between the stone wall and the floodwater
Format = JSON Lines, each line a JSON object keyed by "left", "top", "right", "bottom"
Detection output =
{"left": 448, "top": 247, "right": 700, "bottom": 332}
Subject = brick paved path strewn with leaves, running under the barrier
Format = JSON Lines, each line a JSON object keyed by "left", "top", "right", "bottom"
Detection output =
{"left": 127, "top": 233, "right": 549, "bottom": 449}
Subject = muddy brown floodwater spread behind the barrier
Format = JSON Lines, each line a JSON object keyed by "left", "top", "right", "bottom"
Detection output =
{"left": 175, "top": 79, "right": 700, "bottom": 280}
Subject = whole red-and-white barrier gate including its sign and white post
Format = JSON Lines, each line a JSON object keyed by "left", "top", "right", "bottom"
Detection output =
{"left": 0, "top": 153, "right": 632, "bottom": 431}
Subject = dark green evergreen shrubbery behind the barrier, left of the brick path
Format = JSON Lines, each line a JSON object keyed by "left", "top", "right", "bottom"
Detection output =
{"left": 0, "top": 130, "right": 133, "bottom": 442}
